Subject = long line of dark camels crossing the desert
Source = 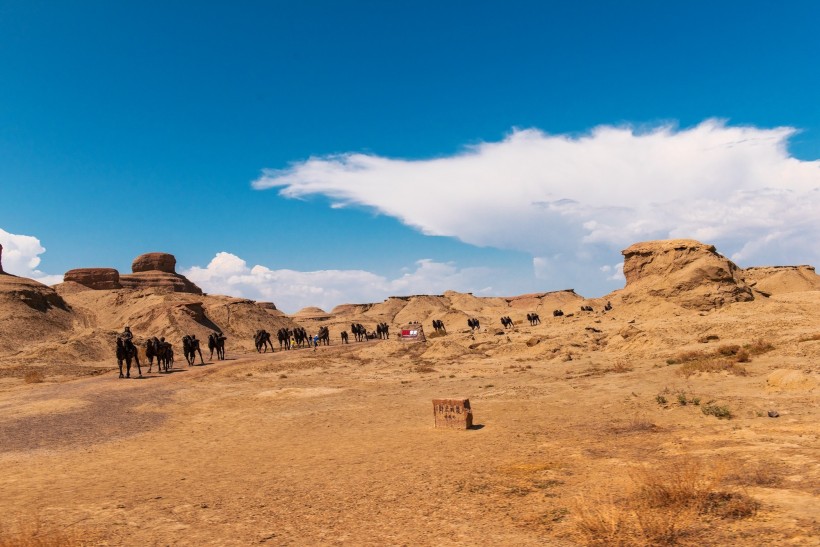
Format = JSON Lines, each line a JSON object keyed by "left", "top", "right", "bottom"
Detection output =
{"left": 115, "top": 302, "right": 612, "bottom": 378}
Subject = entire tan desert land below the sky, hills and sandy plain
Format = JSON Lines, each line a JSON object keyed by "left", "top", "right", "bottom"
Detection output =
{"left": 0, "top": 240, "right": 820, "bottom": 546}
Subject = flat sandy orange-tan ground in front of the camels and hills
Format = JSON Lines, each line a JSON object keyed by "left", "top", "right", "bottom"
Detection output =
{"left": 0, "top": 306, "right": 820, "bottom": 545}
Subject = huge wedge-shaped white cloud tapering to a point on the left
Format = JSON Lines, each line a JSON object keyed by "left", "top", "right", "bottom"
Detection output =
{"left": 253, "top": 120, "right": 820, "bottom": 293}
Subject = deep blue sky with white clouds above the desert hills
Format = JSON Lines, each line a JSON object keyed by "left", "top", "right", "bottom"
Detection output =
{"left": 0, "top": 0, "right": 820, "bottom": 311}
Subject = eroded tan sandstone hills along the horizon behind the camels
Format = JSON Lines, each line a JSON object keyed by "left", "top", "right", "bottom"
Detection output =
{"left": 0, "top": 240, "right": 820, "bottom": 378}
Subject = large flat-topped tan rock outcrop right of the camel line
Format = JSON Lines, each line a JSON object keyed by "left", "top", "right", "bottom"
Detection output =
{"left": 622, "top": 239, "right": 754, "bottom": 310}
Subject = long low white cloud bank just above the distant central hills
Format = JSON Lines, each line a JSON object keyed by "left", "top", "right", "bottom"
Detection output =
{"left": 182, "top": 252, "right": 495, "bottom": 313}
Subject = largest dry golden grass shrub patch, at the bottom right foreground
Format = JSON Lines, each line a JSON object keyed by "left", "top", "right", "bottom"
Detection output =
{"left": 574, "top": 457, "right": 759, "bottom": 546}
